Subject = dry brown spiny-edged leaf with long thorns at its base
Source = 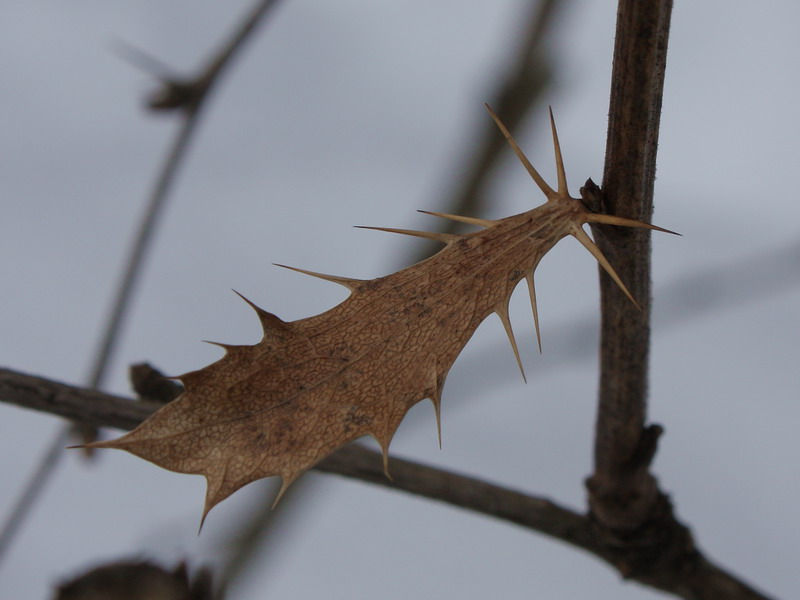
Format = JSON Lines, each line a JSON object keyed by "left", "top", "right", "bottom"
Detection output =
{"left": 86, "top": 106, "right": 676, "bottom": 518}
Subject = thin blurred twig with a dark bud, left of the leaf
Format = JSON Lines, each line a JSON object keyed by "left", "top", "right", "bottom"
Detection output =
{"left": 0, "top": 0, "right": 277, "bottom": 576}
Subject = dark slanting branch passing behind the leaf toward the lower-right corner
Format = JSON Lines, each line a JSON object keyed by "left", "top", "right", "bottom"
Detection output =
{"left": 0, "top": 369, "right": 766, "bottom": 600}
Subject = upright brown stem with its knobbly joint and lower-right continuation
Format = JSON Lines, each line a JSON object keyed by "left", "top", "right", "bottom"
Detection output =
{"left": 587, "top": 0, "right": 776, "bottom": 599}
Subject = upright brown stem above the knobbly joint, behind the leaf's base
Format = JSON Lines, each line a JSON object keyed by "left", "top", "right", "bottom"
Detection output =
{"left": 588, "top": 0, "right": 672, "bottom": 537}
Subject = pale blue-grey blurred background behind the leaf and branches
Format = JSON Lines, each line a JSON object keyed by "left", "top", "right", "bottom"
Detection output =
{"left": 0, "top": 0, "right": 800, "bottom": 600}
